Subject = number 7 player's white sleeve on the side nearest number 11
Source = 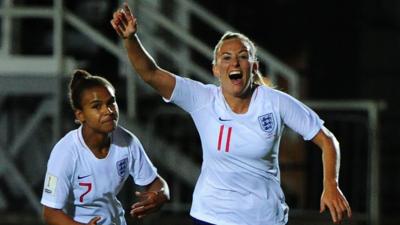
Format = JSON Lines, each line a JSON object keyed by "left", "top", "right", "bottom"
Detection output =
{"left": 130, "top": 137, "right": 157, "bottom": 186}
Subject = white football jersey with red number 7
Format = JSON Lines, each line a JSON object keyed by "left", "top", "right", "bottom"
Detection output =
{"left": 41, "top": 126, "right": 157, "bottom": 225}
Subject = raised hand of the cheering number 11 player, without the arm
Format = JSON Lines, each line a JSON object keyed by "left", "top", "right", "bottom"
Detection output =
{"left": 110, "top": 2, "right": 137, "bottom": 39}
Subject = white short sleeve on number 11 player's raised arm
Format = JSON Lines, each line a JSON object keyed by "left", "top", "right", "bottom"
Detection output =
{"left": 163, "top": 76, "right": 215, "bottom": 113}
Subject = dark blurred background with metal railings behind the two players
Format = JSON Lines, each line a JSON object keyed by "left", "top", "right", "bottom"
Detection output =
{"left": 0, "top": 0, "right": 400, "bottom": 225}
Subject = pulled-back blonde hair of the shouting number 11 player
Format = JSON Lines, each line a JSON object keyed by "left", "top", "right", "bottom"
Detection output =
{"left": 212, "top": 31, "right": 272, "bottom": 86}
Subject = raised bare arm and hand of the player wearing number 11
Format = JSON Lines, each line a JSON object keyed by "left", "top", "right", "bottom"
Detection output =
{"left": 111, "top": 2, "right": 175, "bottom": 99}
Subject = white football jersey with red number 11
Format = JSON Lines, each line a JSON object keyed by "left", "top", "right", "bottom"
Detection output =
{"left": 165, "top": 76, "right": 323, "bottom": 225}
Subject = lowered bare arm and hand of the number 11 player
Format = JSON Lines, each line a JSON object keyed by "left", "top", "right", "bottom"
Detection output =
{"left": 312, "top": 127, "right": 351, "bottom": 223}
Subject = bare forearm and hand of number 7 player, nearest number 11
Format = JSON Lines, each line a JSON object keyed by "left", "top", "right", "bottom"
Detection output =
{"left": 130, "top": 176, "right": 170, "bottom": 219}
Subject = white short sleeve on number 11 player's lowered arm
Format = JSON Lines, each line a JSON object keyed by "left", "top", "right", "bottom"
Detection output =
{"left": 279, "top": 92, "right": 324, "bottom": 141}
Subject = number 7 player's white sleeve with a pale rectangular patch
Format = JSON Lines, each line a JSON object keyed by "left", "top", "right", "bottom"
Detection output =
{"left": 41, "top": 143, "right": 75, "bottom": 209}
